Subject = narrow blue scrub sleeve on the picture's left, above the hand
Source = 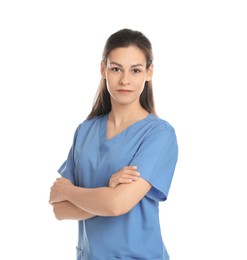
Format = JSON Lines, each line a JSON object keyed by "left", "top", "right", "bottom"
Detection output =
{"left": 58, "top": 127, "right": 79, "bottom": 184}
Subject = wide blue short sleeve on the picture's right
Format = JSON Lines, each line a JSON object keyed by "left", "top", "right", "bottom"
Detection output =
{"left": 130, "top": 121, "right": 178, "bottom": 201}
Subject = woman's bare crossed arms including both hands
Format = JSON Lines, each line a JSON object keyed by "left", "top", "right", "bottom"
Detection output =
{"left": 49, "top": 166, "right": 151, "bottom": 220}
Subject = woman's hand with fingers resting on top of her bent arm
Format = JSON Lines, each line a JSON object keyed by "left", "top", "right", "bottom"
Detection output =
{"left": 109, "top": 166, "right": 140, "bottom": 188}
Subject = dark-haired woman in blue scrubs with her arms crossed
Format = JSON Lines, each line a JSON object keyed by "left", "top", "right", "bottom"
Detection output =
{"left": 49, "top": 29, "right": 178, "bottom": 260}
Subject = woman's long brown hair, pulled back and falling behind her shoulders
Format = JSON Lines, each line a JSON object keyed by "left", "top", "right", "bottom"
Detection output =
{"left": 87, "top": 29, "right": 156, "bottom": 119}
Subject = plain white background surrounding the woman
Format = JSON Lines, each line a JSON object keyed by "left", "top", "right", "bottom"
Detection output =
{"left": 0, "top": 0, "right": 247, "bottom": 260}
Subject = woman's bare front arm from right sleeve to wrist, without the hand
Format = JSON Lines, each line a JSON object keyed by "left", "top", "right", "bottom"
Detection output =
{"left": 64, "top": 179, "right": 151, "bottom": 216}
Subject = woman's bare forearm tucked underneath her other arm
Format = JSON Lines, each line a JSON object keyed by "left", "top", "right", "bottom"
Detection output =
{"left": 53, "top": 201, "right": 95, "bottom": 220}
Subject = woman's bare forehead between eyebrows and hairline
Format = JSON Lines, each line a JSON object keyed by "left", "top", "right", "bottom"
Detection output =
{"left": 108, "top": 46, "right": 146, "bottom": 65}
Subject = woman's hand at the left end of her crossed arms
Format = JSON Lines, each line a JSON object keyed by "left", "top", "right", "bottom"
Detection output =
{"left": 49, "top": 177, "right": 73, "bottom": 204}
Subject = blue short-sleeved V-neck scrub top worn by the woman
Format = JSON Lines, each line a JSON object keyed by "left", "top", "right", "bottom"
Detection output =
{"left": 58, "top": 114, "right": 178, "bottom": 260}
